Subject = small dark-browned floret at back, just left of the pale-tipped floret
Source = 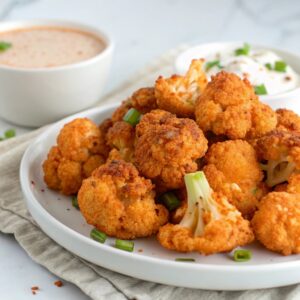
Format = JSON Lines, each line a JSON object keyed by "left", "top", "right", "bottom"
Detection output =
{"left": 131, "top": 87, "right": 157, "bottom": 114}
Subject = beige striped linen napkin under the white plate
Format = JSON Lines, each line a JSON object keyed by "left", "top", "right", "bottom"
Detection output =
{"left": 0, "top": 47, "right": 300, "bottom": 300}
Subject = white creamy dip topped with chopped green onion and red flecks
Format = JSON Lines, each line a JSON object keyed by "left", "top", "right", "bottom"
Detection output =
{"left": 206, "top": 44, "right": 299, "bottom": 95}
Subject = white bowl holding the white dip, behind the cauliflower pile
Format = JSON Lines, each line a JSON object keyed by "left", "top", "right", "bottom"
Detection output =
{"left": 174, "top": 42, "right": 300, "bottom": 114}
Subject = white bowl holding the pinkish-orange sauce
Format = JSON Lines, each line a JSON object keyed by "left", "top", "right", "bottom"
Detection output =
{"left": 0, "top": 20, "right": 113, "bottom": 127}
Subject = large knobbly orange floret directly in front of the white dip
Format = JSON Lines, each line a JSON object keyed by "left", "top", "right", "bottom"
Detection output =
{"left": 195, "top": 71, "right": 277, "bottom": 139}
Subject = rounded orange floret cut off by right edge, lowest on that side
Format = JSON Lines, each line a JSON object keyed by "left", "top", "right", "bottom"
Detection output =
{"left": 251, "top": 192, "right": 300, "bottom": 255}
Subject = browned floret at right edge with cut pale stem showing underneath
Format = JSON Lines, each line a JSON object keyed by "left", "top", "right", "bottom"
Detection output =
{"left": 255, "top": 130, "right": 300, "bottom": 187}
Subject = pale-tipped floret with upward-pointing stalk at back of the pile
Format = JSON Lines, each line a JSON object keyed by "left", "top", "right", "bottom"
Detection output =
{"left": 155, "top": 59, "right": 207, "bottom": 118}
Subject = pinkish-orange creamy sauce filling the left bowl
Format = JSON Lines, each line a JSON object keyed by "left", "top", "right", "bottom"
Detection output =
{"left": 0, "top": 27, "right": 105, "bottom": 69}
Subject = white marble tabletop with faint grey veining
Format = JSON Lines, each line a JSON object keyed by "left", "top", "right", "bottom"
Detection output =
{"left": 0, "top": 0, "right": 300, "bottom": 300}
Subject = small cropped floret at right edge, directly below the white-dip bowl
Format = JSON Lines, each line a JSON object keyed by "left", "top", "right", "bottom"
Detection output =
{"left": 276, "top": 108, "right": 300, "bottom": 132}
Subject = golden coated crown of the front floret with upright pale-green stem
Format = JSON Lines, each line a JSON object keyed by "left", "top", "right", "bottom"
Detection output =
{"left": 158, "top": 193, "right": 254, "bottom": 255}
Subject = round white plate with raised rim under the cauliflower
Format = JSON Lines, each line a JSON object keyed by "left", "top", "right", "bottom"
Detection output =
{"left": 20, "top": 106, "right": 300, "bottom": 290}
